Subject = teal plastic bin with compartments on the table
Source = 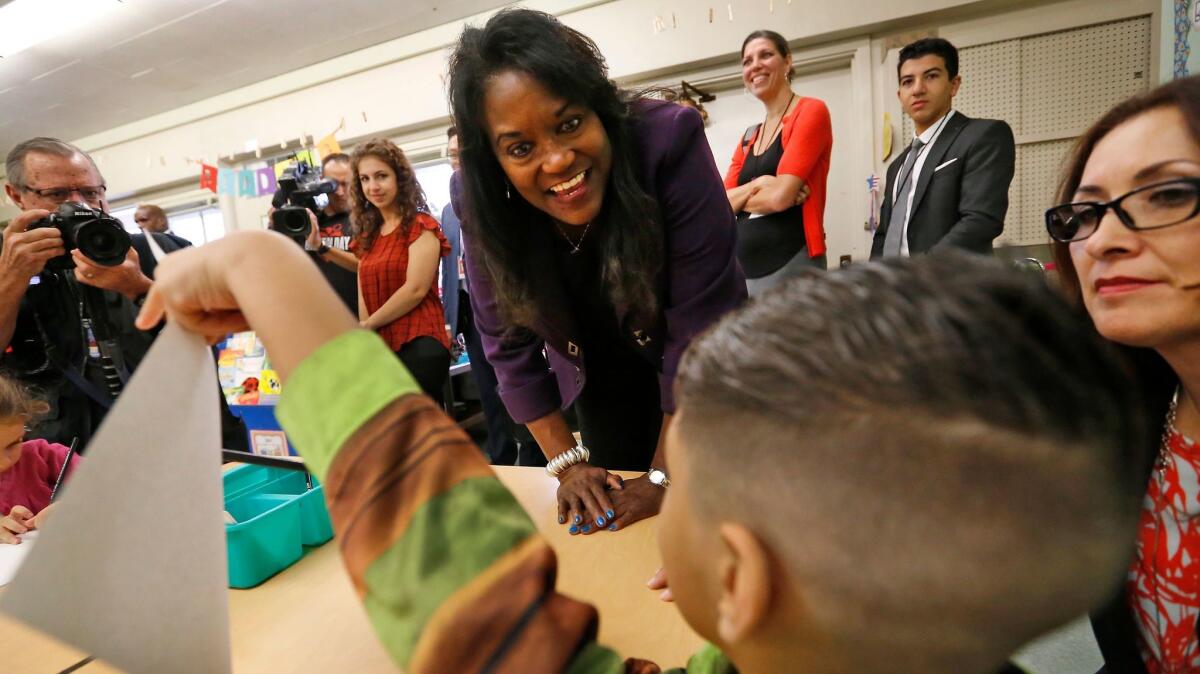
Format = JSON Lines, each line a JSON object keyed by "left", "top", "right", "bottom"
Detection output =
{"left": 224, "top": 465, "right": 334, "bottom": 588}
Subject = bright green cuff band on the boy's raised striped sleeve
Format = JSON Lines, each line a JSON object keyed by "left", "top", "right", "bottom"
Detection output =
{"left": 275, "top": 330, "right": 421, "bottom": 481}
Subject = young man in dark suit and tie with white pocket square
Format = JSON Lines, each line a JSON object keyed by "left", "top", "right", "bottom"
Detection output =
{"left": 871, "top": 37, "right": 1016, "bottom": 260}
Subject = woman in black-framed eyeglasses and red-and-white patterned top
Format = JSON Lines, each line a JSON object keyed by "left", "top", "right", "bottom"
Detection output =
{"left": 1046, "top": 77, "right": 1200, "bottom": 674}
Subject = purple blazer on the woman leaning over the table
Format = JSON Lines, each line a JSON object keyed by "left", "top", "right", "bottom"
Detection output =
{"left": 451, "top": 101, "right": 746, "bottom": 423}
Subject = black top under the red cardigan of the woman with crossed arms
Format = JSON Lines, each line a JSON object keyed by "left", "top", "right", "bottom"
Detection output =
{"left": 738, "top": 133, "right": 806, "bottom": 278}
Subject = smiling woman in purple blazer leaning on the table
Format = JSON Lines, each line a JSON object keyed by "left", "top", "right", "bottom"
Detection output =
{"left": 450, "top": 10, "right": 746, "bottom": 534}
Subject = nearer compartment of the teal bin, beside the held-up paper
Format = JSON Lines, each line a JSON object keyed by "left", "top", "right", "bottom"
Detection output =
{"left": 226, "top": 494, "right": 304, "bottom": 588}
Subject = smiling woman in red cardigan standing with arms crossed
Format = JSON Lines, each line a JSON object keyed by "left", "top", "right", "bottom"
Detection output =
{"left": 725, "top": 30, "right": 833, "bottom": 295}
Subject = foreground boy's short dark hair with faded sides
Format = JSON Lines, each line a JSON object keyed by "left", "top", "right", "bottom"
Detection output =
{"left": 676, "top": 254, "right": 1151, "bottom": 672}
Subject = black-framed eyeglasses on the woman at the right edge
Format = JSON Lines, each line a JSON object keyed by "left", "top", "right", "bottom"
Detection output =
{"left": 1046, "top": 177, "right": 1200, "bottom": 243}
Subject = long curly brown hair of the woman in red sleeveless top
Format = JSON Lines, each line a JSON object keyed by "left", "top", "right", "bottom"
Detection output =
{"left": 350, "top": 138, "right": 430, "bottom": 251}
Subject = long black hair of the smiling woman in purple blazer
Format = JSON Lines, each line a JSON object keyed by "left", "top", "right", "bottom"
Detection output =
{"left": 450, "top": 10, "right": 662, "bottom": 329}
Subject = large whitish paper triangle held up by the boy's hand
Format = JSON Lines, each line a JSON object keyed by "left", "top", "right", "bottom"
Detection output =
{"left": 0, "top": 325, "right": 230, "bottom": 674}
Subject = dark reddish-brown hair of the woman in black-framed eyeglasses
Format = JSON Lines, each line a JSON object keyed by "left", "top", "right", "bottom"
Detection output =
{"left": 1051, "top": 76, "right": 1200, "bottom": 460}
